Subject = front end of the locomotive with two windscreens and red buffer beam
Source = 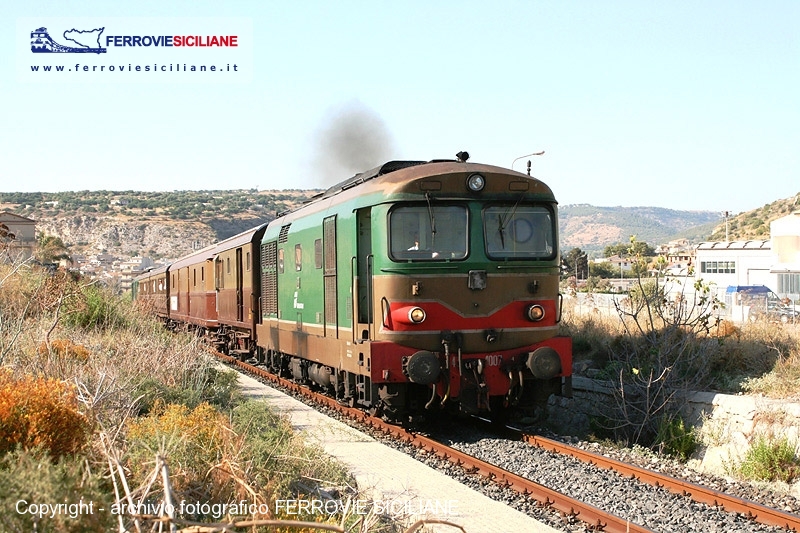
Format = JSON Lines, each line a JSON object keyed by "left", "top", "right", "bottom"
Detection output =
{"left": 369, "top": 162, "right": 572, "bottom": 419}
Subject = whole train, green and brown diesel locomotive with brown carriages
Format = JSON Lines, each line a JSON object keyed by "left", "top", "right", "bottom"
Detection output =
{"left": 134, "top": 156, "right": 572, "bottom": 422}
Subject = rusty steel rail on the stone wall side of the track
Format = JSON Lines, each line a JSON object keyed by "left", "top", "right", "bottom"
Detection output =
{"left": 514, "top": 430, "right": 800, "bottom": 531}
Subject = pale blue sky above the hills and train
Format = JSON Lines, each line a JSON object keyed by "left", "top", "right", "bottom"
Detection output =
{"left": 0, "top": 0, "right": 800, "bottom": 212}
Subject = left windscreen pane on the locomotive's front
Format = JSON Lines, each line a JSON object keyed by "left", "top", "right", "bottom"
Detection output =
{"left": 389, "top": 205, "right": 467, "bottom": 261}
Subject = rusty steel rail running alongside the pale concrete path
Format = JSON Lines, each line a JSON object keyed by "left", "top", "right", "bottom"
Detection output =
{"left": 214, "top": 352, "right": 653, "bottom": 533}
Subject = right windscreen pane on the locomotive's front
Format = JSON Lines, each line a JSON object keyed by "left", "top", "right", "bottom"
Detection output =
{"left": 483, "top": 204, "right": 555, "bottom": 259}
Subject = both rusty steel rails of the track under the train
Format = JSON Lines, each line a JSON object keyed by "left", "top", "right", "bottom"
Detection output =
{"left": 218, "top": 354, "right": 800, "bottom": 533}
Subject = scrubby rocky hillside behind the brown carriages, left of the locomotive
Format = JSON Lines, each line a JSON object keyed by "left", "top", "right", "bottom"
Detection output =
{"left": 0, "top": 190, "right": 319, "bottom": 259}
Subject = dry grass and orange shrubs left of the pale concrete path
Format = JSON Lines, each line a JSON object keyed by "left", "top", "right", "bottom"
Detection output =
{"left": 0, "top": 264, "right": 376, "bottom": 531}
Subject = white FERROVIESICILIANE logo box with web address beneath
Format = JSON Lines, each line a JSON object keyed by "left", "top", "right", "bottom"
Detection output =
{"left": 16, "top": 17, "right": 253, "bottom": 83}
